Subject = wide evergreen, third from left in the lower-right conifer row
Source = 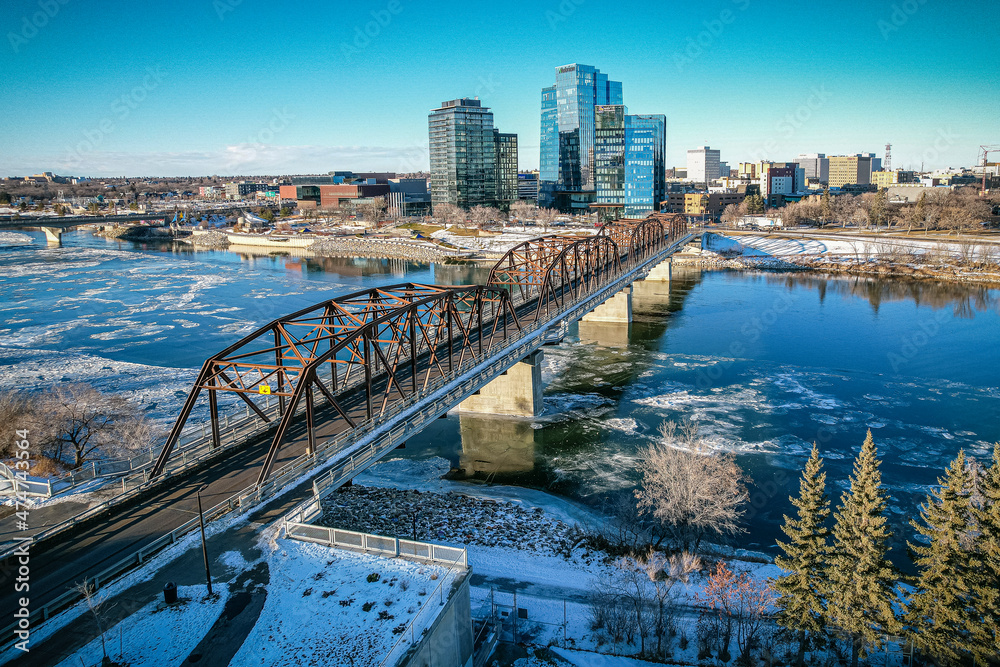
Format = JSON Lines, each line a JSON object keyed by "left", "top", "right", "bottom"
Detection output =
{"left": 905, "top": 452, "right": 976, "bottom": 666}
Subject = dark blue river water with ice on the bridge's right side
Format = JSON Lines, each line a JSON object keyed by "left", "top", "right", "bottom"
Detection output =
{"left": 406, "top": 267, "right": 1000, "bottom": 564}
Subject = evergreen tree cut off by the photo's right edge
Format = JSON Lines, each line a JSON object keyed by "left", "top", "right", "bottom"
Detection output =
{"left": 970, "top": 443, "right": 1000, "bottom": 665}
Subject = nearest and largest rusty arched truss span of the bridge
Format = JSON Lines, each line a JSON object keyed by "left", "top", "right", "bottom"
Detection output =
{"left": 152, "top": 283, "right": 520, "bottom": 482}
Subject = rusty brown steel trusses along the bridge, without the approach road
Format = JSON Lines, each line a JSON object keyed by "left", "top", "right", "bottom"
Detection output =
{"left": 151, "top": 214, "right": 689, "bottom": 485}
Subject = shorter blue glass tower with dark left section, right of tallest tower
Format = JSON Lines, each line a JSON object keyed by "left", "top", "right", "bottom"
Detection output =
{"left": 592, "top": 105, "right": 667, "bottom": 220}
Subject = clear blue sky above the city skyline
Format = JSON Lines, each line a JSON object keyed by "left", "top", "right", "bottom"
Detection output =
{"left": 0, "top": 0, "right": 1000, "bottom": 175}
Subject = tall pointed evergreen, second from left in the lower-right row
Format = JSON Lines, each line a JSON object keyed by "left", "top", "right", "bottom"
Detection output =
{"left": 827, "top": 431, "right": 899, "bottom": 667}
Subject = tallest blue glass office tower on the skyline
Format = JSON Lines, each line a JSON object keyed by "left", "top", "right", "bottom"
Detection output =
{"left": 538, "top": 64, "right": 623, "bottom": 212}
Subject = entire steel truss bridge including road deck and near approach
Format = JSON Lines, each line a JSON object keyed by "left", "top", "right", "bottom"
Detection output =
{"left": 0, "top": 215, "right": 692, "bottom": 641}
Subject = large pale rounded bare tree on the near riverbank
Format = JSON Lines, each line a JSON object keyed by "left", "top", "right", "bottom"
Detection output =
{"left": 635, "top": 422, "right": 748, "bottom": 551}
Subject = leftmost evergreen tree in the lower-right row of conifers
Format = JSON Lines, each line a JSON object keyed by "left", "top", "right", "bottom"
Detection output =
{"left": 774, "top": 443, "right": 830, "bottom": 667}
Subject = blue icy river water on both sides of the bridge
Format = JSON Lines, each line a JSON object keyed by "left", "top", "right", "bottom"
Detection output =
{"left": 0, "top": 232, "right": 1000, "bottom": 556}
